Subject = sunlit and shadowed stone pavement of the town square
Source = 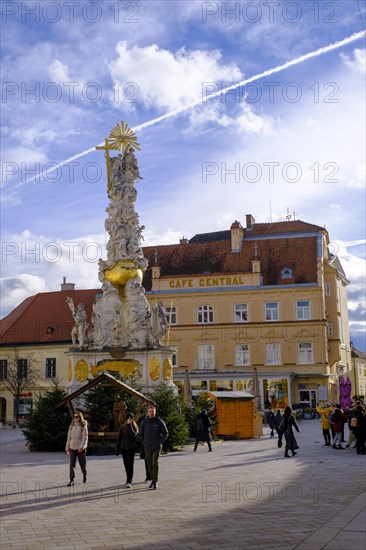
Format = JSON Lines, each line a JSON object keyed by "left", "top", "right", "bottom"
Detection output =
{"left": 0, "top": 420, "right": 366, "bottom": 550}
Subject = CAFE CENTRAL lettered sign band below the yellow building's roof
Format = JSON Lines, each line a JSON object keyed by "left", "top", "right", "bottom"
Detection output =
{"left": 152, "top": 273, "right": 260, "bottom": 291}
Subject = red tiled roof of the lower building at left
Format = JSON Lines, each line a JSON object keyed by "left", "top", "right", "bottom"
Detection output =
{"left": 0, "top": 289, "right": 101, "bottom": 345}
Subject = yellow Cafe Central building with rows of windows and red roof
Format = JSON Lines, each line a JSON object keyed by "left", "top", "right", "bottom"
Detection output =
{"left": 144, "top": 216, "right": 351, "bottom": 408}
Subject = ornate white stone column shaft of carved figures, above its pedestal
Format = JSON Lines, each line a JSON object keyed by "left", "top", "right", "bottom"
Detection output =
{"left": 91, "top": 147, "right": 168, "bottom": 349}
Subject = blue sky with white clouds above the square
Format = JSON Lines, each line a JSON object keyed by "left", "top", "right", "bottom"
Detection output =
{"left": 1, "top": 0, "right": 366, "bottom": 350}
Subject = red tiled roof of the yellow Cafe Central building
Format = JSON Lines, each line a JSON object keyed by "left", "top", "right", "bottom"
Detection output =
{"left": 144, "top": 221, "right": 324, "bottom": 290}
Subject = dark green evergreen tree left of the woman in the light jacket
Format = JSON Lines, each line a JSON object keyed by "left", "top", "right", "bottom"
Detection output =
{"left": 23, "top": 382, "right": 71, "bottom": 452}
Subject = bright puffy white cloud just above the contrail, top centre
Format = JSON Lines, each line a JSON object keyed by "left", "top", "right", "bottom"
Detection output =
{"left": 109, "top": 42, "right": 242, "bottom": 111}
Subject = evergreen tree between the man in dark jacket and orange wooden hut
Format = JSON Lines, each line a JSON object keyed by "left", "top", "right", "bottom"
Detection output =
{"left": 150, "top": 382, "right": 189, "bottom": 451}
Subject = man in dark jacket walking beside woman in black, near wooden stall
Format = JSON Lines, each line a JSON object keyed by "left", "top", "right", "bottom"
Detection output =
{"left": 140, "top": 405, "right": 169, "bottom": 489}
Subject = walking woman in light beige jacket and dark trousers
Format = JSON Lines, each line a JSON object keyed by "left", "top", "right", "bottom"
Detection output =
{"left": 65, "top": 412, "right": 88, "bottom": 487}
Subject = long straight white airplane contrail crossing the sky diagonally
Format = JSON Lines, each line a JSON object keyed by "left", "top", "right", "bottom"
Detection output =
{"left": 13, "top": 31, "right": 366, "bottom": 189}
